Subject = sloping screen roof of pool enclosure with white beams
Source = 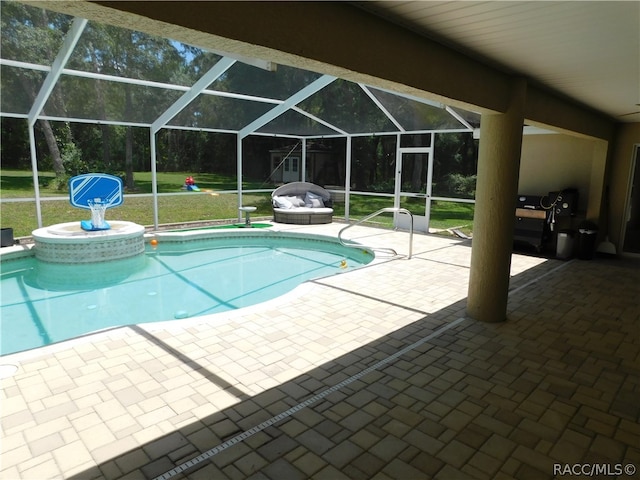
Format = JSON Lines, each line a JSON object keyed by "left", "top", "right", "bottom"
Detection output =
{"left": 0, "top": 2, "right": 480, "bottom": 138}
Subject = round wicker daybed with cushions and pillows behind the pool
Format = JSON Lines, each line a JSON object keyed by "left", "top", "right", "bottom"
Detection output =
{"left": 271, "top": 182, "right": 333, "bottom": 225}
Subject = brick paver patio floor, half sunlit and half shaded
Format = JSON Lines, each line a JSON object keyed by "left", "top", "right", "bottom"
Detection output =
{"left": 0, "top": 224, "right": 640, "bottom": 480}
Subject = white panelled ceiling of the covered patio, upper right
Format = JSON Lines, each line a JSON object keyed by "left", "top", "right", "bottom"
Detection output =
{"left": 357, "top": 0, "right": 640, "bottom": 122}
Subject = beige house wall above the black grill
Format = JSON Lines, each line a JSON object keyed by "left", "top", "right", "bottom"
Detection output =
{"left": 518, "top": 134, "right": 595, "bottom": 216}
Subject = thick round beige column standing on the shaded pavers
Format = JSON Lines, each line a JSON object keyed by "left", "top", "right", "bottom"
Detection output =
{"left": 467, "top": 79, "right": 527, "bottom": 322}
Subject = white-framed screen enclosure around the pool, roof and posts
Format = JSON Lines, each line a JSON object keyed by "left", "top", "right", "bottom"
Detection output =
{"left": 0, "top": 2, "right": 480, "bottom": 231}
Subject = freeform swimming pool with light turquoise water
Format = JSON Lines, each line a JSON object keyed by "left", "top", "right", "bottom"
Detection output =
{"left": 0, "top": 231, "right": 373, "bottom": 355}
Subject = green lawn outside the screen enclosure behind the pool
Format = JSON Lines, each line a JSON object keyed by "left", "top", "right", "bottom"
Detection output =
{"left": 0, "top": 169, "right": 474, "bottom": 237}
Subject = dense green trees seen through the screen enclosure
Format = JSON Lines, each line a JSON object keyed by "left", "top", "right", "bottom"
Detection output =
{"left": 0, "top": 2, "right": 477, "bottom": 197}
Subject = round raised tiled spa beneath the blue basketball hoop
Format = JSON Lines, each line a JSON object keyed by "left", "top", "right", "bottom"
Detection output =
{"left": 32, "top": 220, "right": 144, "bottom": 264}
